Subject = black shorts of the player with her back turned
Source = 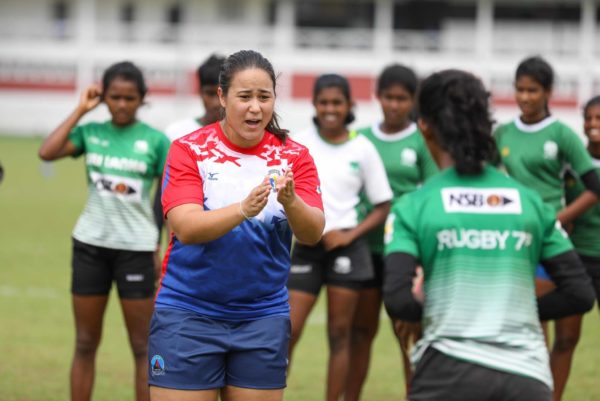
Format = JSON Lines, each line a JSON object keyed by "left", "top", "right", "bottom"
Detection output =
{"left": 408, "top": 347, "right": 552, "bottom": 401}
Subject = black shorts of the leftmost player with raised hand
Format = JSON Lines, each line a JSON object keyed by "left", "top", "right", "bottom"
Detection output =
{"left": 71, "top": 238, "right": 154, "bottom": 299}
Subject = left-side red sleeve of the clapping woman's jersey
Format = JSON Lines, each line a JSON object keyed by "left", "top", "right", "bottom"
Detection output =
{"left": 162, "top": 141, "right": 204, "bottom": 217}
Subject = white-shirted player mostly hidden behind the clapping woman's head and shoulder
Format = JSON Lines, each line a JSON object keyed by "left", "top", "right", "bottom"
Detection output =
{"left": 165, "top": 54, "right": 225, "bottom": 141}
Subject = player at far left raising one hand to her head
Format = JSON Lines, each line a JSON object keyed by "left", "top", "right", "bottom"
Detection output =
{"left": 39, "top": 62, "right": 170, "bottom": 401}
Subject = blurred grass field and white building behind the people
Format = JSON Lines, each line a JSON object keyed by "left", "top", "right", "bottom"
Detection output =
{"left": 0, "top": 0, "right": 600, "bottom": 401}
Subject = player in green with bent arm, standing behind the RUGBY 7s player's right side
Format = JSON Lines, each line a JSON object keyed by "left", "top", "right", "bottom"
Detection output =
{"left": 495, "top": 57, "right": 600, "bottom": 401}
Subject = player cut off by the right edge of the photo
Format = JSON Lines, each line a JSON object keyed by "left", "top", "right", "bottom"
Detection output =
{"left": 565, "top": 96, "right": 600, "bottom": 299}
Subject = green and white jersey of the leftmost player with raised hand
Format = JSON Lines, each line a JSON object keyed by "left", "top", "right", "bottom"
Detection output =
{"left": 69, "top": 121, "right": 170, "bottom": 251}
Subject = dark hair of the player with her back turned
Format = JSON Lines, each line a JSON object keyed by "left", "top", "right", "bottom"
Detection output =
{"left": 418, "top": 70, "right": 495, "bottom": 175}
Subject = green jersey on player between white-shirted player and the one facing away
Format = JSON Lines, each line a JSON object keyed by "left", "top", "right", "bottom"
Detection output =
{"left": 358, "top": 123, "right": 438, "bottom": 254}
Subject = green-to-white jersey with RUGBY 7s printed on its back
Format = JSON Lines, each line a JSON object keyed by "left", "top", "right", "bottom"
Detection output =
{"left": 385, "top": 166, "right": 572, "bottom": 387}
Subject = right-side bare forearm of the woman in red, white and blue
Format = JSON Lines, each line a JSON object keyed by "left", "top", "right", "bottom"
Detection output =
{"left": 284, "top": 195, "right": 325, "bottom": 245}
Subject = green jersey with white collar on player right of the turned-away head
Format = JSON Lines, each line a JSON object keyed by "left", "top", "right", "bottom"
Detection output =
{"left": 494, "top": 117, "right": 593, "bottom": 212}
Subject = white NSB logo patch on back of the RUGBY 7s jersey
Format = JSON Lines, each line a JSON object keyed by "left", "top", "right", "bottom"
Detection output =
{"left": 442, "top": 187, "right": 521, "bottom": 214}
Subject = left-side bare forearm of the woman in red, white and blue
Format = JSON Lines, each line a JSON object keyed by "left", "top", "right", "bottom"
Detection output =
{"left": 167, "top": 203, "right": 244, "bottom": 245}
